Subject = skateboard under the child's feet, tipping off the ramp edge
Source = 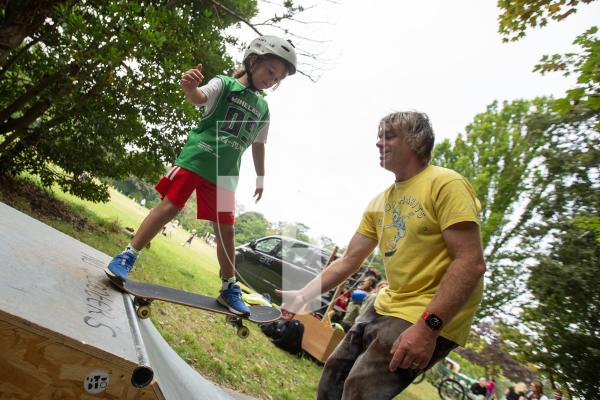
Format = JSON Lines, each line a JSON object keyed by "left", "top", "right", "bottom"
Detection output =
{"left": 106, "top": 272, "right": 281, "bottom": 339}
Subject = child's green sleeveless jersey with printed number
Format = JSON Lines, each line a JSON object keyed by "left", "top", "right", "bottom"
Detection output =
{"left": 175, "top": 75, "right": 269, "bottom": 191}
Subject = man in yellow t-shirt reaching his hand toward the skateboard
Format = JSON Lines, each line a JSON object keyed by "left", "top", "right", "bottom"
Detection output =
{"left": 280, "top": 112, "right": 485, "bottom": 400}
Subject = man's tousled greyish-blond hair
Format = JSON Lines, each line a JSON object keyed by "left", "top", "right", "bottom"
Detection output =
{"left": 379, "top": 111, "right": 435, "bottom": 163}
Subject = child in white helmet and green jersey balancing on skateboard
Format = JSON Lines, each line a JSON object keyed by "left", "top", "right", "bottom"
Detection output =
{"left": 108, "top": 36, "right": 296, "bottom": 315}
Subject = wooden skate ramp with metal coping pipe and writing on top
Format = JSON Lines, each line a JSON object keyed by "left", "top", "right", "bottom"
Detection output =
{"left": 0, "top": 203, "right": 231, "bottom": 400}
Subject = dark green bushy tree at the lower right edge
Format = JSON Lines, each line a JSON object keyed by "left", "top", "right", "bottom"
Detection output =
{"left": 496, "top": 220, "right": 600, "bottom": 399}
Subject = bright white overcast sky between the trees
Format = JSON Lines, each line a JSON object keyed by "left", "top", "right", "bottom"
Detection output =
{"left": 231, "top": 0, "right": 600, "bottom": 246}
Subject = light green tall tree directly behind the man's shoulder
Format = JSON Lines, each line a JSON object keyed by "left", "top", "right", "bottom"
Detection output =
{"left": 432, "top": 98, "right": 557, "bottom": 315}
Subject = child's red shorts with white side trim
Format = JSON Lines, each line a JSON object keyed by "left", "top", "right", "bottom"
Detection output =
{"left": 154, "top": 167, "right": 235, "bottom": 225}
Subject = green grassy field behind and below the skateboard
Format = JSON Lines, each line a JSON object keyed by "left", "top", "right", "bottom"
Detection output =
{"left": 0, "top": 176, "right": 438, "bottom": 400}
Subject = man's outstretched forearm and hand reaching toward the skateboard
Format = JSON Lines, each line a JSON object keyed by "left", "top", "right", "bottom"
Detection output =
{"left": 276, "top": 233, "right": 377, "bottom": 319}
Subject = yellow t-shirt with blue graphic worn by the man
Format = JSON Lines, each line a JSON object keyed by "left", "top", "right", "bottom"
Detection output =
{"left": 357, "top": 165, "right": 483, "bottom": 346}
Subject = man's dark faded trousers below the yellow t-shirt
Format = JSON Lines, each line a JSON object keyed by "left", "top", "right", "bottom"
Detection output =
{"left": 317, "top": 306, "right": 457, "bottom": 400}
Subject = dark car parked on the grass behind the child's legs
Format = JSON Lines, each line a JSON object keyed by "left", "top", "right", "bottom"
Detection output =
{"left": 235, "top": 236, "right": 360, "bottom": 312}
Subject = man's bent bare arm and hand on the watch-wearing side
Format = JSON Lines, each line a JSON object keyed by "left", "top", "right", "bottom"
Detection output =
{"left": 389, "top": 222, "right": 485, "bottom": 371}
